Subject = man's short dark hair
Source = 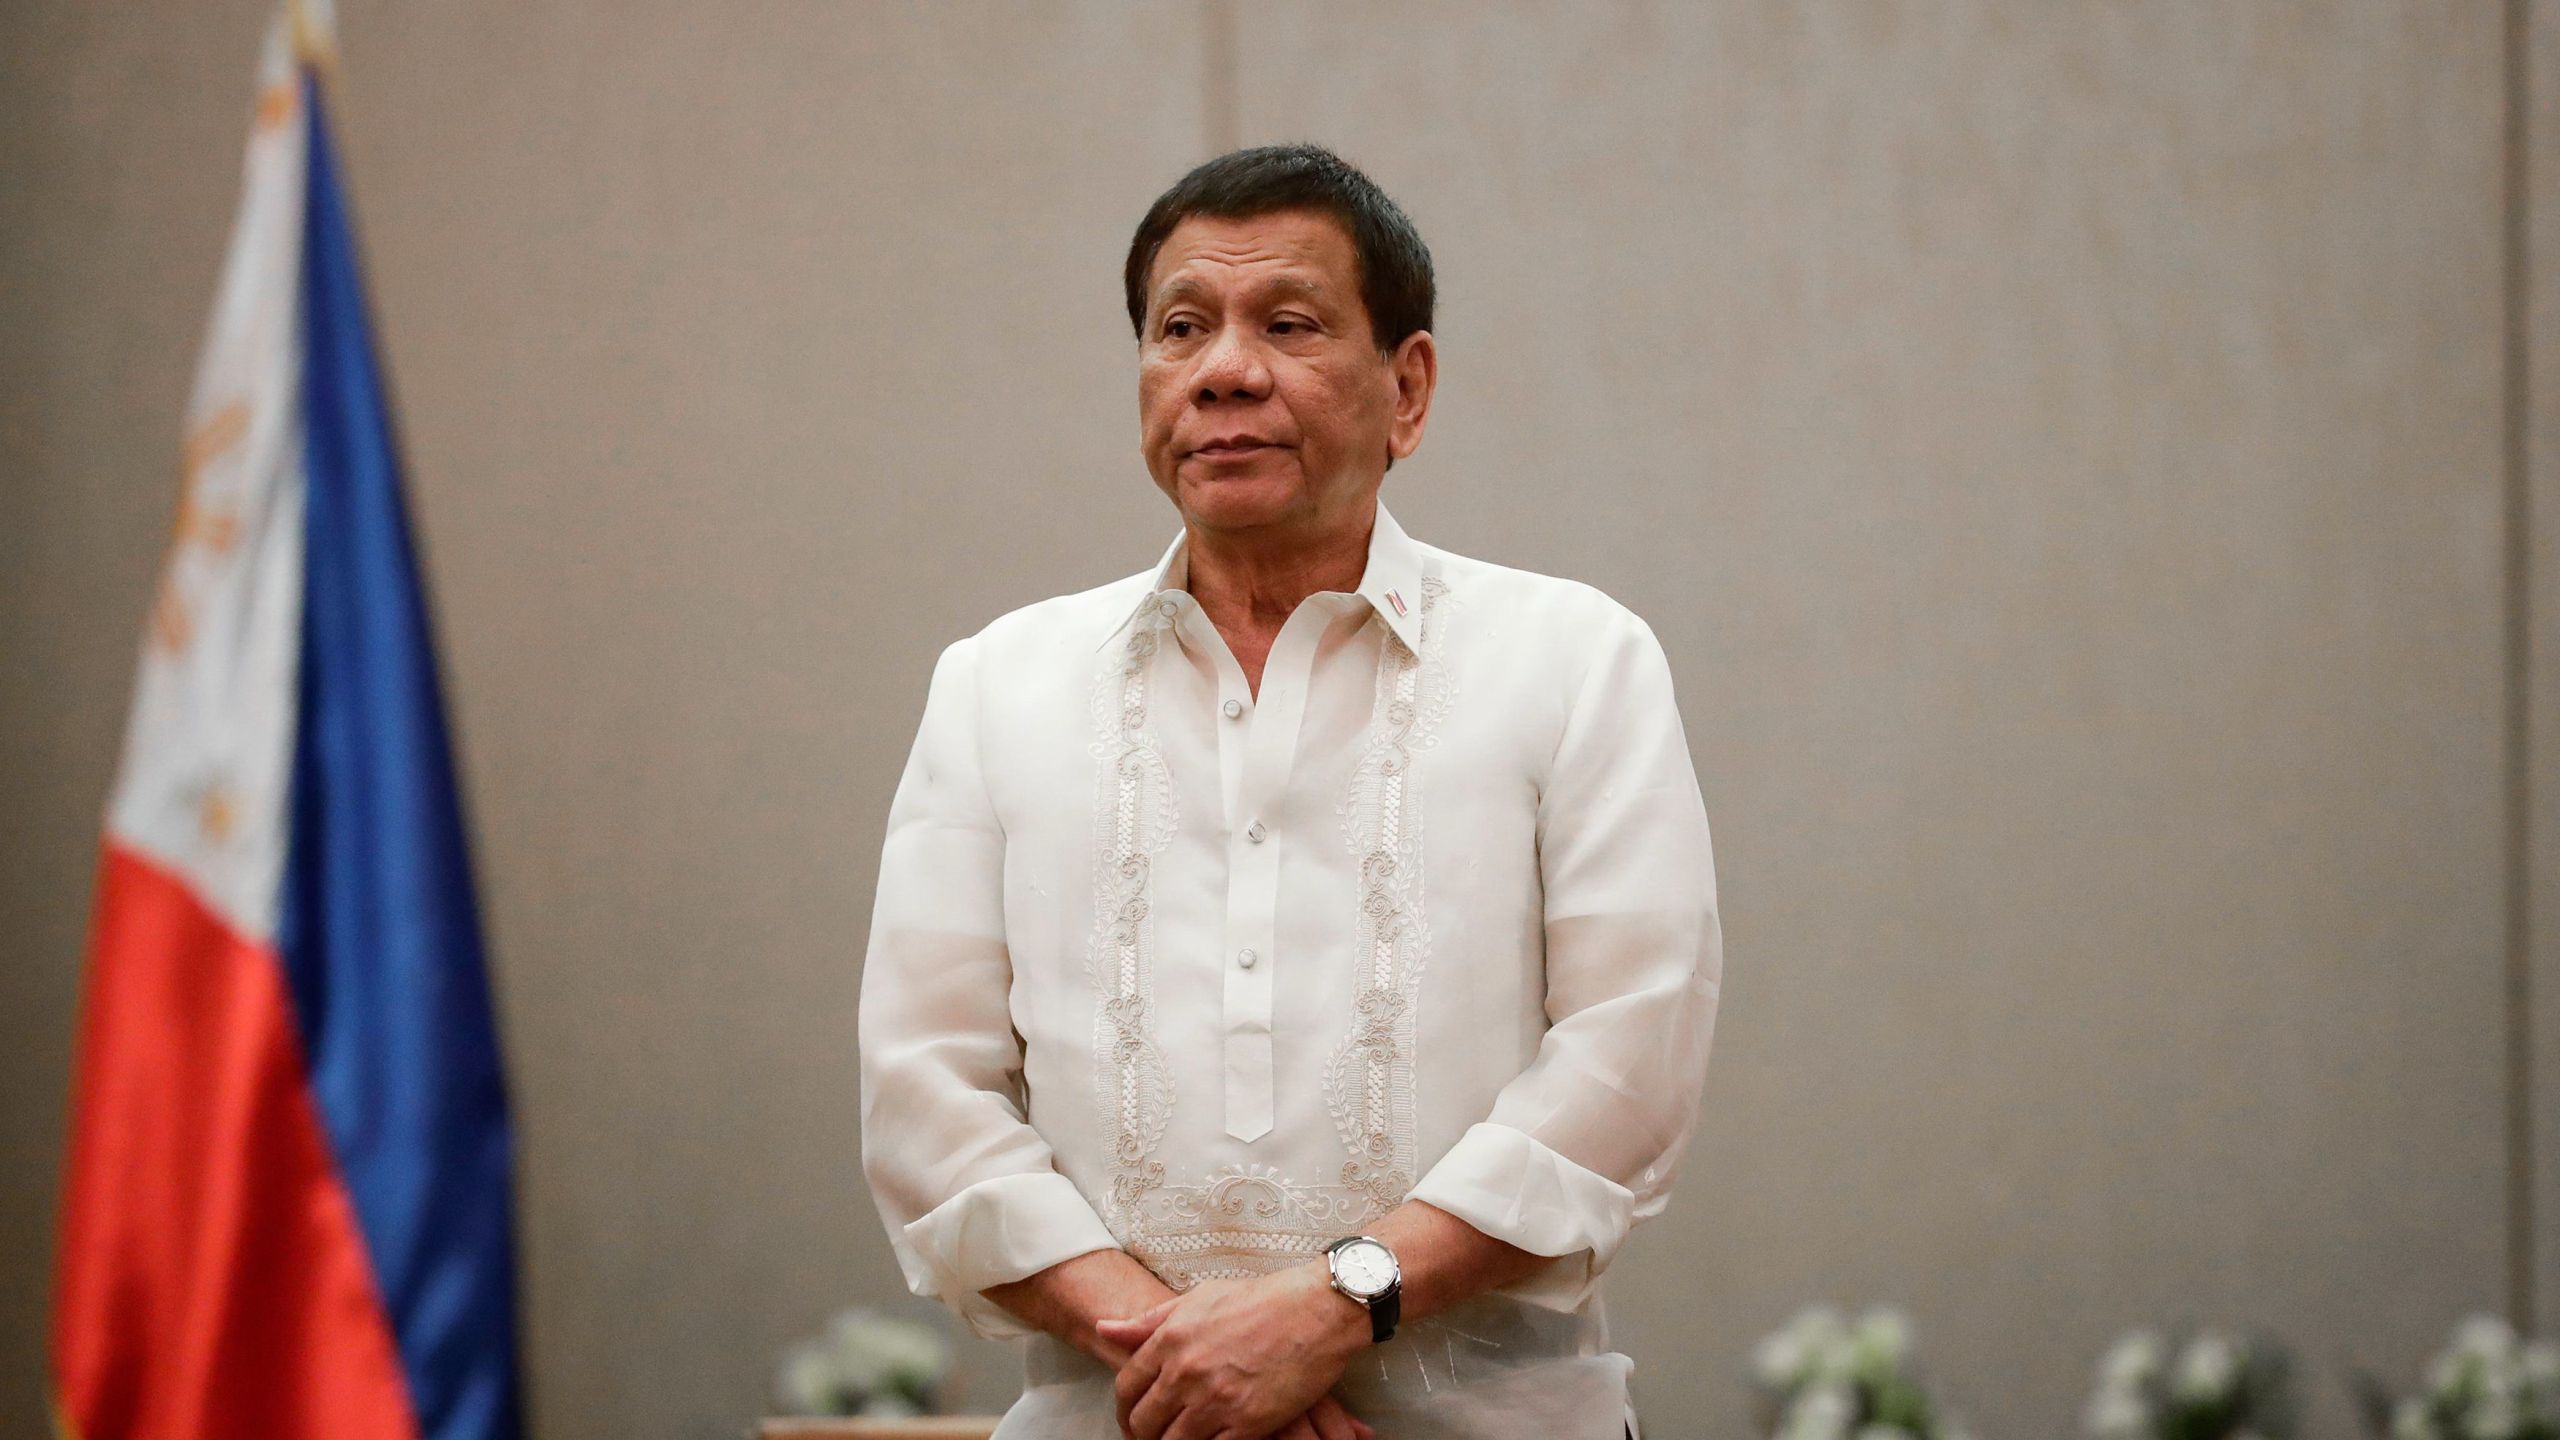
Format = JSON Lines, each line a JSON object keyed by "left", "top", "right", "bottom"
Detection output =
{"left": 1121, "top": 143, "right": 1431, "bottom": 354}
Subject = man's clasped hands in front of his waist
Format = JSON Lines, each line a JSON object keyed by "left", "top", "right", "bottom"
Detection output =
{"left": 1098, "top": 1266, "right": 1372, "bottom": 1440}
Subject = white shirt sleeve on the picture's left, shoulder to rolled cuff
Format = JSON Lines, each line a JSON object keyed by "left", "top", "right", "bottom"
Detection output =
{"left": 858, "top": 641, "right": 1116, "bottom": 1338}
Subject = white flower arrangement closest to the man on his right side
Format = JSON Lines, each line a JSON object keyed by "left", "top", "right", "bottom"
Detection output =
{"left": 1751, "top": 1304, "right": 1971, "bottom": 1440}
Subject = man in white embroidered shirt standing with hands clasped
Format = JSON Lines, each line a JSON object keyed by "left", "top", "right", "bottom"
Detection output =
{"left": 860, "top": 146, "right": 1723, "bottom": 1440}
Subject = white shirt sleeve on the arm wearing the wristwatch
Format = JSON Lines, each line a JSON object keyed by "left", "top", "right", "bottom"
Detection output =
{"left": 1411, "top": 607, "right": 1723, "bottom": 1309}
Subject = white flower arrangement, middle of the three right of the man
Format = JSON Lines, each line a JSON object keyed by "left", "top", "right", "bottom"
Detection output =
{"left": 2081, "top": 1327, "right": 2296, "bottom": 1440}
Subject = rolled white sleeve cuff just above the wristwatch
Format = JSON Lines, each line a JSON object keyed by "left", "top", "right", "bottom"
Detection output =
{"left": 1411, "top": 1122, "right": 1636, "bottom": 1309}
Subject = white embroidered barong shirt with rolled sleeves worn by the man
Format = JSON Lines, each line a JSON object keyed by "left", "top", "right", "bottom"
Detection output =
{"left": 860, "top": 507, "right": 1723, "bottom": 1440}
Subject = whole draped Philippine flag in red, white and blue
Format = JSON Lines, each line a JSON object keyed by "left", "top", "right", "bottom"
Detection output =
{"left": 51, "top": 0, "right": 517, "bottom": 1440}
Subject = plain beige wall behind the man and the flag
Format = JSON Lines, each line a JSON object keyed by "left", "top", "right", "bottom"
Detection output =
{"left": 0, "top": 0, "right": 2560, "bottom": 1440}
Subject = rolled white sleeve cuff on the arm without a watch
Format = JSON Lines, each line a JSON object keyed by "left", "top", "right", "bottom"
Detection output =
{"left": 896, "top": 1171, "right": 1119, "bottom": 1340}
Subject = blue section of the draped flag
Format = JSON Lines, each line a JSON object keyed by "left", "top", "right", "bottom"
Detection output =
{"left": 276, "top": 69, "right": 520, "bottom": 1440}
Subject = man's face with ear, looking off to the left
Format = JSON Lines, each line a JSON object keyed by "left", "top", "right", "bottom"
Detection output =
{"left": 1137, "top": 210, "right": 1434, "bottom": 530}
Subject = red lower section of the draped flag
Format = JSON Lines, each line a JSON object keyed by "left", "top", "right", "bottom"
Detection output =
{"left": 54, "top": 843, "right": 417, "bottom": 1440}
